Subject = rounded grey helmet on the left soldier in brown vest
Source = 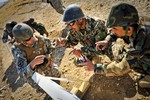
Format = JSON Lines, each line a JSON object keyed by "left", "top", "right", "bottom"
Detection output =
{"left": 12, "top": 23, "right": 33, "bottom": 42}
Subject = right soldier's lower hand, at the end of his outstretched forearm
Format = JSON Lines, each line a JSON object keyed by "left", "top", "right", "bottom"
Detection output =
{"left": 82, "top": 59, "right": 94, "bottom": 71}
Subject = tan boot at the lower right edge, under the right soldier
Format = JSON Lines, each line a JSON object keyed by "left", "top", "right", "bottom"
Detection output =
{"left": 139, "top": 75, "right": 150, "bottom": 88}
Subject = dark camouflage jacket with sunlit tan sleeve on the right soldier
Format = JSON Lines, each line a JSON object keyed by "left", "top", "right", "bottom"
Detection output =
{"left": 95, "top": 25, "right": 150, "bottom": 76}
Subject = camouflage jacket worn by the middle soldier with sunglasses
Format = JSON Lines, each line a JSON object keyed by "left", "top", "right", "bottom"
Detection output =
{"left": 63, "top": 17, "right": 107, "bottom": 58}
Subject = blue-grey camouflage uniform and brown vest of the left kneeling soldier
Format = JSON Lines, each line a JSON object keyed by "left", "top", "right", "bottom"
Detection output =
{"left": 12, "top": 36, "right": 59, "bottom": 78}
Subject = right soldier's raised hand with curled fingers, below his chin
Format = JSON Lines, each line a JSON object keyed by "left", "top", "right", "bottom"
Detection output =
{"left": 95, "top": 40, "right": 108, "bottom": 51}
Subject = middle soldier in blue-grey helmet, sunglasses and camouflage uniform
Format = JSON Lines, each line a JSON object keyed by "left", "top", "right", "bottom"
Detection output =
{"left": 56, "top": 4, "right": 107, "bottom": 64}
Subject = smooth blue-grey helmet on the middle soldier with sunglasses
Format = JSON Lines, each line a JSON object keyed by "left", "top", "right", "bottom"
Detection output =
{"left": 63, "top": 4, "right": 84, "bottom": 22}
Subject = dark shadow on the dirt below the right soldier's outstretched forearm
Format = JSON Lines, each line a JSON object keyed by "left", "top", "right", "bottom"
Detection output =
{"left": 83, "top": 75, "right": 137, "bottom": 100}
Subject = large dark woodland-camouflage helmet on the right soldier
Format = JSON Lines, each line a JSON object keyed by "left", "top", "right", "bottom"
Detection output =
{"left": 106, "top": 3, "right": 139, "bottom": 28}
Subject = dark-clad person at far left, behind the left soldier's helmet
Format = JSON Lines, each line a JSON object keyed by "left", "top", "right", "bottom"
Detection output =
{"left": 2, "top": 21, "right": 17, "bottom": 44}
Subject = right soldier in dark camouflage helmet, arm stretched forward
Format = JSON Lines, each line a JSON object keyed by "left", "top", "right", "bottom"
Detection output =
{"left": 84, "top": 3, "right": 150, "bottom": 88}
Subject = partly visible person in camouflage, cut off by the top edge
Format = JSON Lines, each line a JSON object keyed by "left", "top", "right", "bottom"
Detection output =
{"left": 42, "top": 0, "right": 65, "bottom": 14}
